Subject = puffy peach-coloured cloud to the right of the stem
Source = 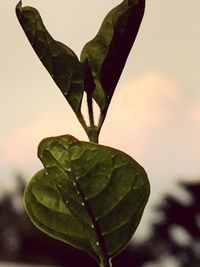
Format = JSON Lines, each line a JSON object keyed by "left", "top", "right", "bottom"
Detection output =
{"left": 101, "top": 73, "right": 182, "bottom": 156}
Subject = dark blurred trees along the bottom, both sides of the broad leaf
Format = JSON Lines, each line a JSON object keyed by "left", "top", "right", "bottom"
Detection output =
{"left": 0, "top": 176, "right": 200, "bottom": 267}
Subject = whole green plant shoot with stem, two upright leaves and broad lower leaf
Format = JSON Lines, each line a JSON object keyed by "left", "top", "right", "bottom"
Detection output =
{"left": 16, "top": 0, "right": 150, "bottom": 267}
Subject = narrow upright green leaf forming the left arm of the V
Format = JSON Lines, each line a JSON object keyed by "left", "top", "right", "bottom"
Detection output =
{"left": 16, "top": 1, "right": 84, "bottom": 112}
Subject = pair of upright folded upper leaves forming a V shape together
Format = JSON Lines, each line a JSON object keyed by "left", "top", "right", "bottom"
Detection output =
{"left": 16, "top": 0, "right": 145, "bottom": 136}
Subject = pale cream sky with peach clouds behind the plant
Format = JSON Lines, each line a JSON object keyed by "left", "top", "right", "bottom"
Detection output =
{"left": 0, "top": 0, "right": 200, "bottom": 242}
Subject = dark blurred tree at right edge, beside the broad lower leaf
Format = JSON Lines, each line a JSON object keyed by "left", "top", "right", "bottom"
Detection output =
{"left": 145, "top": 182, "right": 200, "bottom": 267}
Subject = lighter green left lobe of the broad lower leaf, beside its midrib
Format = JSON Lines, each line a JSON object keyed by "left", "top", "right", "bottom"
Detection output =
{"left": 24, "top": 169, "right": 96, "bottom": 258}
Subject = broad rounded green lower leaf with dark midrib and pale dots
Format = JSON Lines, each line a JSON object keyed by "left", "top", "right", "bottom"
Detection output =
{"left": 25, "top": 135, "right": 150, "bottom": 262}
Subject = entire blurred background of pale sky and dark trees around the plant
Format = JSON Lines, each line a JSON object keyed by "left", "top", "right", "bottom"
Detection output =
{"left": 0, "top": 0, "right": 200, "bottom": 267}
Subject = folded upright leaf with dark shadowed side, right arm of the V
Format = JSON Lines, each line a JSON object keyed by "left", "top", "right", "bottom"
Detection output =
{"left": 81, "top": 0, "right": 145, "bottom": 109}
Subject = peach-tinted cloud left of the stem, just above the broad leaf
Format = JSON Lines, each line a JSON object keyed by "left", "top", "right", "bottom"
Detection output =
{"left": 0, "top": 111, "right": 85, "bottom": 165}
